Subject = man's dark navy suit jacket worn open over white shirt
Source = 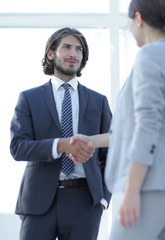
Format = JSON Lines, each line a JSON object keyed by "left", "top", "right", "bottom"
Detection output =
{"left": 10, "top": 81, "right": 111, "bottom": 215}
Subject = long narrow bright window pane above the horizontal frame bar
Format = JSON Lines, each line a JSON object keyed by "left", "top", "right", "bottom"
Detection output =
{"left": 0, "top": 0, "right": 109, "bottom": 13}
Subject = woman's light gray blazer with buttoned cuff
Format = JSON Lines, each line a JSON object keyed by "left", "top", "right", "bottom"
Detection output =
{"left": 105, "top": 38, "right": 165, "bottom": 193}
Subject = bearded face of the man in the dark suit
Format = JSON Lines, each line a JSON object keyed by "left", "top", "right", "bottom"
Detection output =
{"left": 53, "top": 35, "right": 83, "bottom": 77}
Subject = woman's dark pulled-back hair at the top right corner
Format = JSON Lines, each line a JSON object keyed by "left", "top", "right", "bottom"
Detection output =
{"left": 128, "top": 0, "right": 165, "bottom": 32}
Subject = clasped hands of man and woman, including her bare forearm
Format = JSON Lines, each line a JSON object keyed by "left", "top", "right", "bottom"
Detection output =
{"left": 57, "top": 133, "right": 109, "bottom": 163}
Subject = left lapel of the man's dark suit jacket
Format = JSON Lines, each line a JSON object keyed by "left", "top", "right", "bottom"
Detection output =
{"left": 42, "top": 81, "right": 61, "bottom": 131}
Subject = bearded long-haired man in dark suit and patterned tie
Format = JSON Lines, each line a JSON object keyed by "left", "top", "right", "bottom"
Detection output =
{"left": 10, "top": 28, "right": 111, "bottom": 240}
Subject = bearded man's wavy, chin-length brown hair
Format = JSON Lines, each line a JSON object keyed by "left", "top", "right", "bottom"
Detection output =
{"left": 42, "top": 28, "right": 89, "bottom": 77}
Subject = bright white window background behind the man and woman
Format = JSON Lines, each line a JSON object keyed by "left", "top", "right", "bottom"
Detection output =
{"left": 0, "top": 0, "right": 138, "bottom": 240}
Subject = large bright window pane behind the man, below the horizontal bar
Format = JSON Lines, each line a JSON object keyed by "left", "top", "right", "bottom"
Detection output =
{"left": 0, "top": 25, "right": 110, "bottom": 207}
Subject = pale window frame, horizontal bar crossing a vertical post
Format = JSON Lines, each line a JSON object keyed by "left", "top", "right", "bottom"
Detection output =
{"left": 0, "top": 0, "right": 128, "bottom": 111}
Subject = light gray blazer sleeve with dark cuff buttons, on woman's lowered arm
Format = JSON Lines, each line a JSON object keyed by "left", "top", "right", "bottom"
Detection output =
{"left": 128, "top": 45, "right": 165, "bottom": 166}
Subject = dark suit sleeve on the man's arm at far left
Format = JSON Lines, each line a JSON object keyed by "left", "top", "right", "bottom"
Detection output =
{"left": 10, "top": 91, "right": 54, "bottom": 162}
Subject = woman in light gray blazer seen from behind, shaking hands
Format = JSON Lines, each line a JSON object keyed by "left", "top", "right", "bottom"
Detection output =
{"left": 71, "top": 0, "right": 165, "bottom": 240}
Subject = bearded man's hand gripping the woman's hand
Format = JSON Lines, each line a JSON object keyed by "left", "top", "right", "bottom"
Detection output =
{"left": 57, "top": 138, "right": 94, "bottom": 163}
